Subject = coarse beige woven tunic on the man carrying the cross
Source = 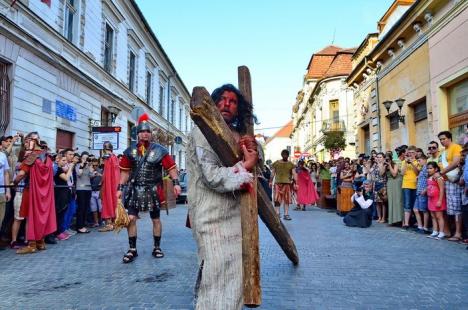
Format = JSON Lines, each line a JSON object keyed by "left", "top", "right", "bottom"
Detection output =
{"left": 187, "top": 127, "right": 252, "bottom": 310}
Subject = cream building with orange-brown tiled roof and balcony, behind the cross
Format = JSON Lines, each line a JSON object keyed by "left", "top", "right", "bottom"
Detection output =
{"left": 292, "top": 45, "right": 355, "bottom": 161}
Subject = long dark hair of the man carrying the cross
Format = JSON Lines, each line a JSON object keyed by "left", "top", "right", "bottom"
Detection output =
{"left": 211, "top": 84, "right": 258, "bottom": 134}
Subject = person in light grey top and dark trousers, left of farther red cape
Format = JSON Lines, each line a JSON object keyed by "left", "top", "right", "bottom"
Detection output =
{"left": 75, "top": 152, "right": 93, "bottom": 234}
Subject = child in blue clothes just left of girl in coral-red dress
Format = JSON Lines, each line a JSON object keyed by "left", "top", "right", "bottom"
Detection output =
{"left": 413, "top": 154, "right": 429, "bottom": 234}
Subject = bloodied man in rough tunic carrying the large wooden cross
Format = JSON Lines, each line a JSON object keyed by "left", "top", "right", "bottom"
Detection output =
{"left": 187, "top": 84, "right": 258, "bottom": 309}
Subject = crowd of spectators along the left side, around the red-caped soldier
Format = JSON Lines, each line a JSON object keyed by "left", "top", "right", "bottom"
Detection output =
{"left": 0, "top": 134, "right": 118, "bottom": 254}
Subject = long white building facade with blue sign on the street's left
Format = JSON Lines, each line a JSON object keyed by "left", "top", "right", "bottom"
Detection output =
{"left": 0, "top": 0, "right": 192, "bottom": 168}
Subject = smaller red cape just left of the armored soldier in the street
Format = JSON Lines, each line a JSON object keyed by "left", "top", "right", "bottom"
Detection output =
{"left": 101, "top": 154, "right": 120, "bottom": 219}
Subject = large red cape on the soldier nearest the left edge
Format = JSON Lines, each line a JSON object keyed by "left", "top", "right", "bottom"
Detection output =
{"left": 26, "top": 158, "right": 57, "bottom": 240}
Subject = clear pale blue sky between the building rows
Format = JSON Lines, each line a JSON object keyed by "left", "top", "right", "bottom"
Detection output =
{"left": 136, "top": 0, "right": 393, "bottom": 136}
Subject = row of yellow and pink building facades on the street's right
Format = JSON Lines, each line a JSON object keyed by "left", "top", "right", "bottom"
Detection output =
{"left": 347, "top": 0, "right": 468, "bottom": 153}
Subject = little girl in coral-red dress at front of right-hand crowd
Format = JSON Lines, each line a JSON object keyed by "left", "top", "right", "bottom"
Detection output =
{"left": 426, "top": 162, "right": 447, "bottom": 240}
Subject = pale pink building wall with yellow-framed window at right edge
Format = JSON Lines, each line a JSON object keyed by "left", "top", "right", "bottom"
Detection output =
{"left": 429, "top": 1, "right": 468, "bottom": 144}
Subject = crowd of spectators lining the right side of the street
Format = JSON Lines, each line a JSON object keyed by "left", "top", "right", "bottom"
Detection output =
{"left": 266, "top": 131, "right": 468, "bottom": 249}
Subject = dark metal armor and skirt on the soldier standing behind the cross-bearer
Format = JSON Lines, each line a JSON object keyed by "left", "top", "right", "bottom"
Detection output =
{"left": 124, "top": 143, "right": 168, "bottom": 211}
